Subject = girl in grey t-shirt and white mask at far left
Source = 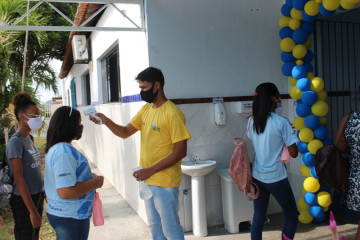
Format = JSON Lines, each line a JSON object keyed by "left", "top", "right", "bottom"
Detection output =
{"left": 6, "top": 92, "right": 45, "bottom": 240}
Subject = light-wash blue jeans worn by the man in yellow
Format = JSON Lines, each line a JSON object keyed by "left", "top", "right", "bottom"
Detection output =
{"left": 145, "top": 185, "right": 184, "bottom": 240}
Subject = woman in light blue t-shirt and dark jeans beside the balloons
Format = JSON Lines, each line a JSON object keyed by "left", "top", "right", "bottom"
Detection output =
{"left": 247, "top": 83, "right": 299, "bottom": 240}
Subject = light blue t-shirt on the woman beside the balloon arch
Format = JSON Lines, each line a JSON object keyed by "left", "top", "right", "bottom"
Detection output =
{"left": 247, "top": 113, "right": 298, "bottom": 183}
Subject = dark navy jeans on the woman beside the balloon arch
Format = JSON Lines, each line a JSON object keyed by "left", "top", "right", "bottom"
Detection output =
{"left": 251, "top": 178, "right": 299, "bottom": 240}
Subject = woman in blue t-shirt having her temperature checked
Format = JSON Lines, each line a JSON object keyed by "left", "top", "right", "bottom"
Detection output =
{"left": 44, "top": 106, "right": 104, "bottom": 240}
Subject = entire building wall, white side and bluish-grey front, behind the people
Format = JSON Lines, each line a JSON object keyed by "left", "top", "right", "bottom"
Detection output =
{"left": 64, "top": 0, "right": 302, "bottom": 231}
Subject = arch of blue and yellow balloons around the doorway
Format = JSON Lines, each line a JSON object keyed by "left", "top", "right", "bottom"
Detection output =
{"left": 279, "top": 0, "right": 360, "bottom": 224}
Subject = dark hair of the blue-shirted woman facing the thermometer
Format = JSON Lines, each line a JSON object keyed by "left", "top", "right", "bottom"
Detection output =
{"left": 45, "top": 106, "right": 80, "bottom": 153}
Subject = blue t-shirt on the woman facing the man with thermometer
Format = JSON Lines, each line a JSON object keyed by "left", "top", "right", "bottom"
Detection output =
{"left": 44, "top": 143, "right": 95, "bottom": 219}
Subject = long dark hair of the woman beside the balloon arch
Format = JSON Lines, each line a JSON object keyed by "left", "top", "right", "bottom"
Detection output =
{"left": 253, "top": 82, "right": 279, "bottom": 134}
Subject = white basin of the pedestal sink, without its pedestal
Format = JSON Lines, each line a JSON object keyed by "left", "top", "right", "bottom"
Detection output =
{"left": 181, "top": 160, "right": 216, "bottom": 177}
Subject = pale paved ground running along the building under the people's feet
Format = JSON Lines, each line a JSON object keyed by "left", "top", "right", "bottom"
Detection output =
{"left": 89, "top": 165, "right": 357, "bottom": 240}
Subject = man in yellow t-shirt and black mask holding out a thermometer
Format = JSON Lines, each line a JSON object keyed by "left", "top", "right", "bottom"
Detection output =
{"left": 90, "top": 67, "right": 191, "bottom": 240}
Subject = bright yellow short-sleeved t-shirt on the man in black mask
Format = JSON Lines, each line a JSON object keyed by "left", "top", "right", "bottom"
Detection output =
{"left": 130, "top": 100, "right": 191, "bottom": 187}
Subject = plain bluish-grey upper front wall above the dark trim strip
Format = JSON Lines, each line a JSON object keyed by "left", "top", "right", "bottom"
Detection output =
{"left": 146, "top": 0, "right": 288, "bottom": 98}
